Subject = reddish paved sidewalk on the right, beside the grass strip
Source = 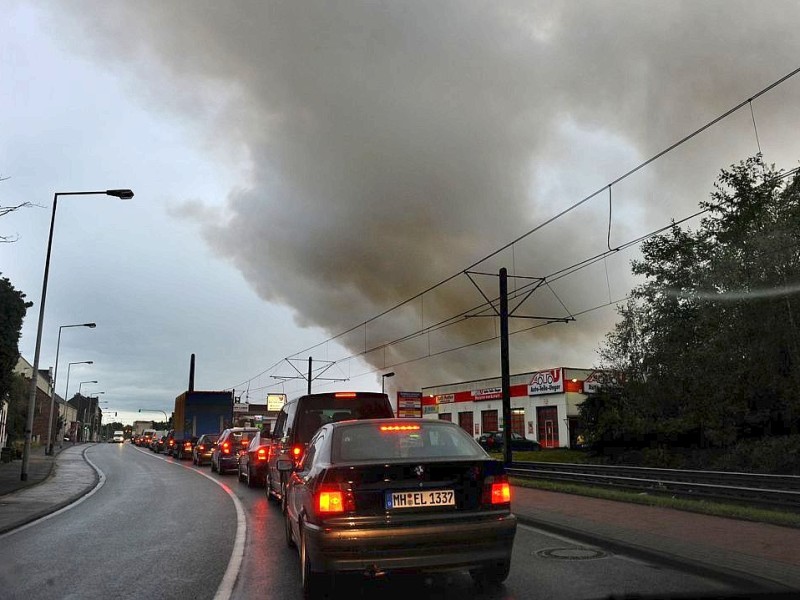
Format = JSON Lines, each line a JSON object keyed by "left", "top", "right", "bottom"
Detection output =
{"left": 511, "top": 487, "right": 800, "bottom": 591}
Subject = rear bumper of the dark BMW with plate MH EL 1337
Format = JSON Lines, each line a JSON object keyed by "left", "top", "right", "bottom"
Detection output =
{"left": 304, "top": 513, "right": 517, "bottom": 573}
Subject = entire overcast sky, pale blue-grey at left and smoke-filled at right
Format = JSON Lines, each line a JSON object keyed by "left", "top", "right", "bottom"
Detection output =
{"left": 0, "top": 0, "right": 800, "bottom": 422}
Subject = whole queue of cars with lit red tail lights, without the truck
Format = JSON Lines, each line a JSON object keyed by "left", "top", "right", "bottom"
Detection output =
{"left": 126, "top": 392, "right": 516, "bottom": 597}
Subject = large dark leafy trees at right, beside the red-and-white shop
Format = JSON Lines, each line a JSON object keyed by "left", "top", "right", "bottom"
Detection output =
{"left": 585, "top": 155, "right": 800, "bottom": 446}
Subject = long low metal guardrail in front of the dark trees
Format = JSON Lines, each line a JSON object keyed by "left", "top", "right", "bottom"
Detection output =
{"left": 506, "top": 462, "right": 800, "bottom": 510}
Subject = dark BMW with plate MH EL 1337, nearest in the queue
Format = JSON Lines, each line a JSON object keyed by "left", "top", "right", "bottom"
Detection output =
{"left": 278, "top": 419, "right": 517, "bottom": 596}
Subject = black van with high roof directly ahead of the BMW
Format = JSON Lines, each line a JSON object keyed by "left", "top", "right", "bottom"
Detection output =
{"left": 266, "top": 392, "right": 394, "bottom": 500}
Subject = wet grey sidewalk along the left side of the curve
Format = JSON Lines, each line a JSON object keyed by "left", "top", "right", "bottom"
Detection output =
{"left": 0, "top": 443, "right": 99, "bottom": 535}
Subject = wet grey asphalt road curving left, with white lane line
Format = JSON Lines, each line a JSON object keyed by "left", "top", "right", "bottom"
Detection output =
{"left": 0, "top": 443, "right": 735, "bottom": 600}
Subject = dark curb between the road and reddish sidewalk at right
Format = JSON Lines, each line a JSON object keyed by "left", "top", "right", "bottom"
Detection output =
{"left": 514, "top": 513, "right": 797, "bottom": 593}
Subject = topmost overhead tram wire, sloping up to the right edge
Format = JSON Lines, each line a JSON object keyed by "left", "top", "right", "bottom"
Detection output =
{"left": 236, "top": 67, "right": 800, "bottom": 392}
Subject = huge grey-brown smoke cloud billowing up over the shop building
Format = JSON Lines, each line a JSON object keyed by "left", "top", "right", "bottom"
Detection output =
{"left": 45, "top": 0, "right": 800, "bottom": 385}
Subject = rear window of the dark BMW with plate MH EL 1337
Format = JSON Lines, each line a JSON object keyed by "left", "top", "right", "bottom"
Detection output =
{"left": 332, "top": 420, "right": 487, "bottom": 462}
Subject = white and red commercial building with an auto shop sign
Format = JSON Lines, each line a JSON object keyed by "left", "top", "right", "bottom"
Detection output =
{"left": 422, "top": 367, "right": 597, "bottom": 448}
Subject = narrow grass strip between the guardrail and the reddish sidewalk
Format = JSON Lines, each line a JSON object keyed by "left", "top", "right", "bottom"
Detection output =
{"left": 509, "top": 477, "right": 800, "bottom": 529}
